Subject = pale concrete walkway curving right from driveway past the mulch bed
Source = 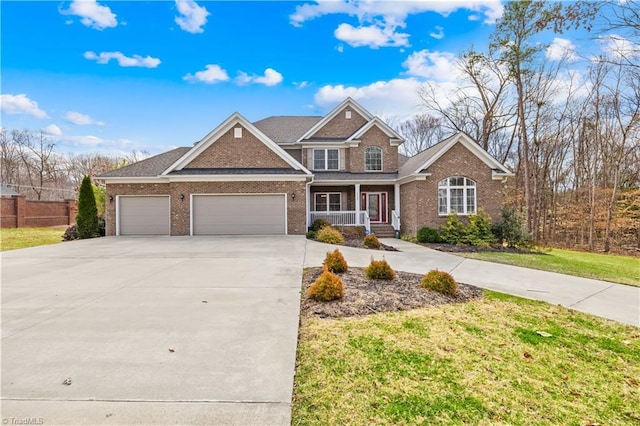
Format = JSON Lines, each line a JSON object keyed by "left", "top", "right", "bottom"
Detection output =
{"left": 305, "top": 239, "right": 640, "bottom": 326}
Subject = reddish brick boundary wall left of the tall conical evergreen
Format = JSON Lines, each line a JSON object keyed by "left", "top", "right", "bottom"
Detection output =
{"left": 0, "top": 195, "right": 77, "bottom": 228}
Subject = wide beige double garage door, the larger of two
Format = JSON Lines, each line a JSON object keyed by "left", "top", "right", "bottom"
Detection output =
{"left": 191, "top": 194, "right": 286, "bottom": 235}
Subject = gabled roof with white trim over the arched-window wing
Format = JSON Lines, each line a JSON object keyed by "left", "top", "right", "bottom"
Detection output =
{"left": 400, "top": 132, "right": 513, "bottom": 177}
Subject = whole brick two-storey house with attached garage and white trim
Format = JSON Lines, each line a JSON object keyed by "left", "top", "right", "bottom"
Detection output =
{"left": 98, "top": 98, "right": 513, "bottom": 235}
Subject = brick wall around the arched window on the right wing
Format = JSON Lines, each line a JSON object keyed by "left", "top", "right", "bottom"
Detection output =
{"left": 400, "top": 143, "right": 504, "bottom": 235}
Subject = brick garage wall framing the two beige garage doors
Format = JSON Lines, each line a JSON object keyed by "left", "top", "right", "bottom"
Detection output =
{"left": 106, "top": 181, "right": 307, "bottom": 235}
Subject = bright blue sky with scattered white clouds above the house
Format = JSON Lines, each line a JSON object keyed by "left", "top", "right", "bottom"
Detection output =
{"left": 0, "top": 0, "right": 594, "bottom": 154}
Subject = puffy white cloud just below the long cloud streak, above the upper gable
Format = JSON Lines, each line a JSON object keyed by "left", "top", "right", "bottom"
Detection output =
{"left": 333, "top": 24, "right": 409, "bottom": 49}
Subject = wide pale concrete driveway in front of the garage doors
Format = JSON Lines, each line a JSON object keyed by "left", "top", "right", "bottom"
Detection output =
{"left": 1, "top": 236, "right": 305, "bottom": 425}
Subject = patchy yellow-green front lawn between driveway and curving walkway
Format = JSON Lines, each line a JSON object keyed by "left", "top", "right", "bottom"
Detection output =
{"left": 292, "top": 292, "right": 640, "bottom": 425}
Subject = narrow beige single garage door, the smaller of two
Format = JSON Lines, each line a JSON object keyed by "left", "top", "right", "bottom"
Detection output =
{"left": 118, "top": 196, "right": 171, "bottom": 235}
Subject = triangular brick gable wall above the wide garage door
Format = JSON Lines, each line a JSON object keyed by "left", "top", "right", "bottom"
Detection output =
{"left": 185, "top": 125, "right": 291, "bottom": 169}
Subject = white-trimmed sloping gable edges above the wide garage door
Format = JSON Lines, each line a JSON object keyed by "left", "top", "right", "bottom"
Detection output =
{"left": 162, "top": 112, "right": 311, "bottom": 175}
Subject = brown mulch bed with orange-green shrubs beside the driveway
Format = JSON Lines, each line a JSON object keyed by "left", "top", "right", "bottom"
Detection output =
{"left": 300, "top": 268, "right": 483, "bottom": 318}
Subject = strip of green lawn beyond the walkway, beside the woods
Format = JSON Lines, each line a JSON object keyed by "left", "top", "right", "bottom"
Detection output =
{"left": 456, "top": 248, "right": 640, "bottom": 287}
